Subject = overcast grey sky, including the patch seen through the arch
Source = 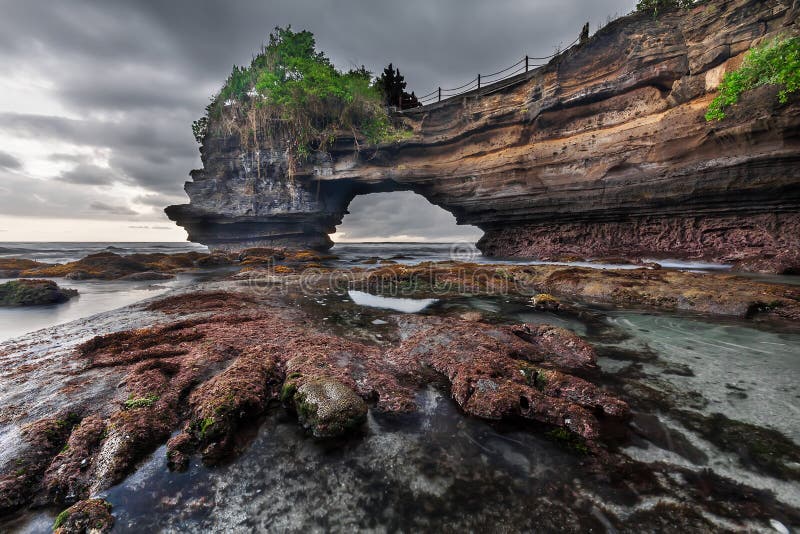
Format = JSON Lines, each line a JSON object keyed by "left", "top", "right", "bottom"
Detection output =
{"left": 0, "top": 0, "right": 635, "bottom": 241}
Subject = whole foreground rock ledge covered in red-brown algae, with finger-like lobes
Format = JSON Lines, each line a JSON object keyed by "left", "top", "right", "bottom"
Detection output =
{"left": 0, "top": 290, "right": 628, "bottom": 517}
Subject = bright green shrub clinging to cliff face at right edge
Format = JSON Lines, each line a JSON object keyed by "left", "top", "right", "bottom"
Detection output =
{"left": 706, "top": 37, "right": 800, "bottom": 121}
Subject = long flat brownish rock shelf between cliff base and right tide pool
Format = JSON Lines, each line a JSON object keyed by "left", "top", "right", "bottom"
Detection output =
{"left": 340, "top": 262, "right": 800, "bottom": 322}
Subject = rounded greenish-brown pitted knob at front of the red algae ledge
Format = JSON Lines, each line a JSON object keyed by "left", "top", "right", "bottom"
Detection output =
{"left": 294, "top": 378, "right": 367, "bottom": 438}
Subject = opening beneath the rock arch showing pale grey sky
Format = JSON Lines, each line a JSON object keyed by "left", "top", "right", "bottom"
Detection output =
{"left": 331, "top": 191, "right": 483, "bottom": 243}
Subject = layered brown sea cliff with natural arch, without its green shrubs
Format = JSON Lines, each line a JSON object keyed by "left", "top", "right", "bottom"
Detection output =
{"left": 167, "top": 0, "right": 800, "bottom": 271}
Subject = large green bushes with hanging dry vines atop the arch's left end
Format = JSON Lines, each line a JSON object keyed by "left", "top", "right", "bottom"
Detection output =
{"left": 193, "top": 27, "right": 406, "bottom": 166}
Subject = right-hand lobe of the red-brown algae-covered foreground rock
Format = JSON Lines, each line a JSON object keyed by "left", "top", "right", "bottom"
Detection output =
{"left": 387, "top": 318, "right": 628, "bottom": 439}
